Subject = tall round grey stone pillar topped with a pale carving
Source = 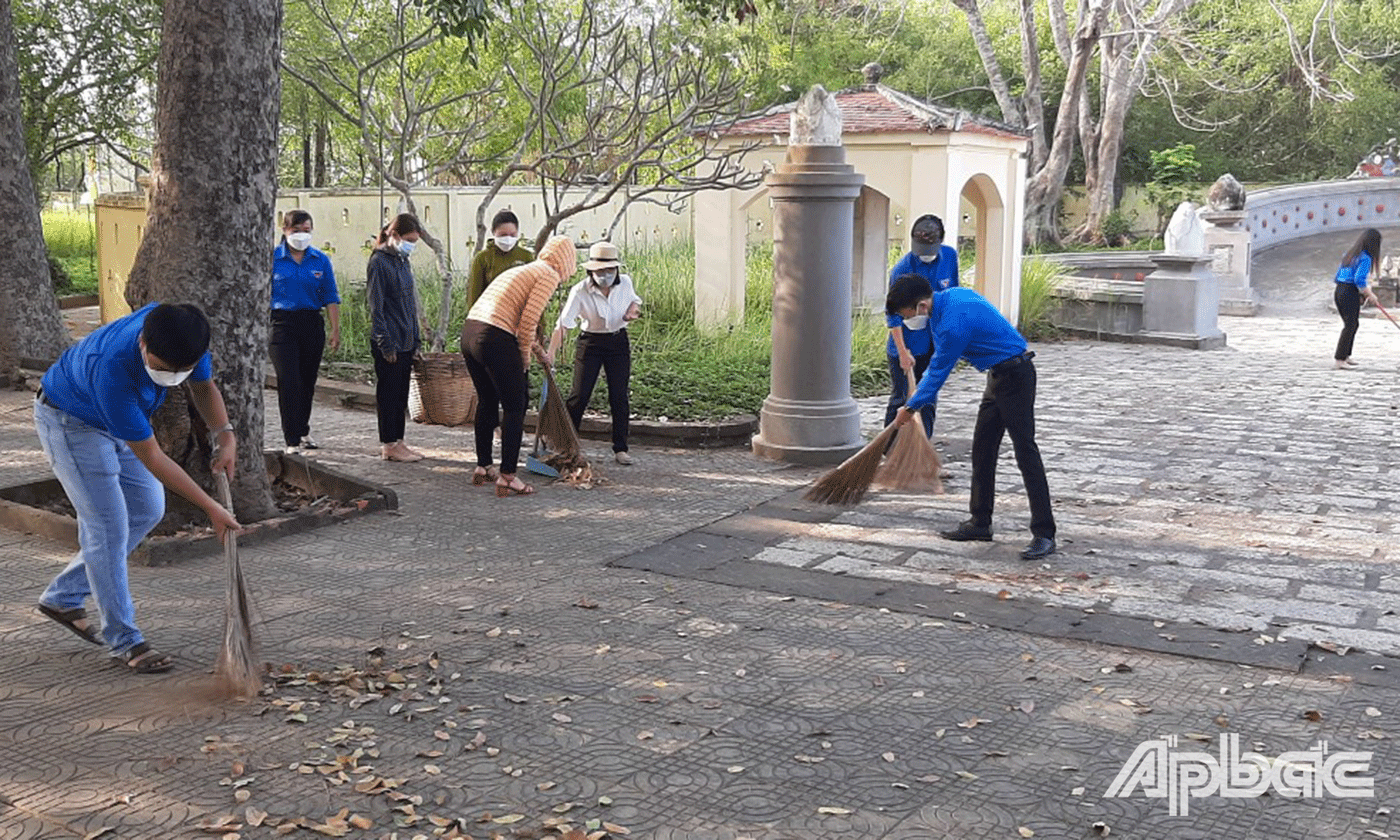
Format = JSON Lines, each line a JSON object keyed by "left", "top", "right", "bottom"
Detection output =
{"left": 753, "top": 85, "right": 865, "bottom": 463}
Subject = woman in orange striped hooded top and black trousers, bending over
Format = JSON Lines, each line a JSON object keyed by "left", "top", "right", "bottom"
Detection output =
{"left": 462, "top": 237, "right": 578, "bottom": 496}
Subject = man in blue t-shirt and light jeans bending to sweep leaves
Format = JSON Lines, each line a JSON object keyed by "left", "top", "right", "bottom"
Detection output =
{"left": 34, "top": 304, "right": 239, "bottom": 673}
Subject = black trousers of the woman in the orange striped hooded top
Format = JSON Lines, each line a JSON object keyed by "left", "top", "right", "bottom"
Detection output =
{"left": 462, "top": 319, "right": 529, "bottom": 476}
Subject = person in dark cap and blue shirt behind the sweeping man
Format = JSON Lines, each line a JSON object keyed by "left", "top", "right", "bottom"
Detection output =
{"left": 885, "top": 214, "right": 958, "bottom": 437}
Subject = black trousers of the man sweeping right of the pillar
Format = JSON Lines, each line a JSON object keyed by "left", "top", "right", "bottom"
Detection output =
{"left": 969, "top": 360, "right": 1054, "bottom": 538}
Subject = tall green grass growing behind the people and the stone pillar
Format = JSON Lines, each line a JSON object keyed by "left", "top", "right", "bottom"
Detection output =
{"left": 336, "top": 242, "right": 889, "bottom": 420}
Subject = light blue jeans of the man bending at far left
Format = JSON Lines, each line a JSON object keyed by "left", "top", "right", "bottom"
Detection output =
{"left": 34, "top": 400, "right": 165, "bottom": 654}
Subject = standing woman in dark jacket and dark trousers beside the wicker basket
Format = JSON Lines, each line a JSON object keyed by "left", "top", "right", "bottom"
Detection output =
{"left": 365, "top": 213, "right": 423, "bottom": 461}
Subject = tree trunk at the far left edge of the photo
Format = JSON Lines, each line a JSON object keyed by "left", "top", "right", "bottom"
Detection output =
{"left": 0, "top": 3, "right": 69, "bottom": 375}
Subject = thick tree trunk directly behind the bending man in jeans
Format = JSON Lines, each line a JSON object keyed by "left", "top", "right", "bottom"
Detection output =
{"left": 126, "top": 0, "right": 283, "bottom": 522}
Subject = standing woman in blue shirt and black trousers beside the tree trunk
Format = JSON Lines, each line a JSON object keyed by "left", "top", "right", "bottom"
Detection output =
{"left": 269, "top": 210, "right": 340, "bottom": 452}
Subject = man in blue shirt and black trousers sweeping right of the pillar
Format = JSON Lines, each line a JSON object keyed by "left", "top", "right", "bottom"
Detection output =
{"left": 885, "top": 276, "right": 1056, "bottom": 560}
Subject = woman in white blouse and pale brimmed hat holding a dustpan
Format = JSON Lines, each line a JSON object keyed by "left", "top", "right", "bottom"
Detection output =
{"left": 546, "top": 242, "right": 641, "bottom": 466}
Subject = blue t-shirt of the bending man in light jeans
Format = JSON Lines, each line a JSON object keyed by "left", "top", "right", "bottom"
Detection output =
{"left": 43, "top": 304, "right": 214, "bottom": 441}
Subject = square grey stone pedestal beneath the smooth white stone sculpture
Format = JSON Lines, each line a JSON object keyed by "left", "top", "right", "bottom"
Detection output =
{"left": 1142, "top": 253, "right": 1225, "bottom": 350}
